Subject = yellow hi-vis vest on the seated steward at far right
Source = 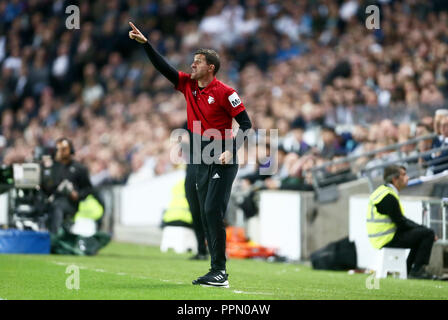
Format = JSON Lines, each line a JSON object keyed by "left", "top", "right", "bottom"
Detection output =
{"left": 367, "top": 185, "right": 404, "bottom": 249}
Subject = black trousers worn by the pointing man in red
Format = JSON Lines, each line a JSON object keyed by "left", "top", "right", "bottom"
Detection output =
{"left": 192, "top": 164, "right": 238, "bottom": 270}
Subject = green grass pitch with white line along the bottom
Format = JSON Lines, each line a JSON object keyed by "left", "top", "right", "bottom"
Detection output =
{"left": 0, "top": 243, "right": 448, "bottom": 300}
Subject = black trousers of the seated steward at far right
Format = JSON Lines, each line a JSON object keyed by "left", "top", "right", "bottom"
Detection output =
{"left": 384, "top": 226, "right": 434, "bottom": 272}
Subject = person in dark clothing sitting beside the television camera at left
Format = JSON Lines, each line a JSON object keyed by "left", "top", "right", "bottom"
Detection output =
{"left": 44, "top": 137, "right": 93, "bottom": 234}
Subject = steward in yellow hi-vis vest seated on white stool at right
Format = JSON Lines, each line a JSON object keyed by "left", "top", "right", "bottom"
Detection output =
{"left": 366, "top": 165, "right": 436, "bottom": 279}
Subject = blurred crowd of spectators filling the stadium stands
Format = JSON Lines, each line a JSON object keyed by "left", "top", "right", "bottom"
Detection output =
{"left": 0, "top": 0, "right": 448, "bottom": 190}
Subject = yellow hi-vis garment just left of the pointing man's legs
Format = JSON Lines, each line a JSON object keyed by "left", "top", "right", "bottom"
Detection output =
{"left": 162, "top": 179, "right": 193, "bottom": 228}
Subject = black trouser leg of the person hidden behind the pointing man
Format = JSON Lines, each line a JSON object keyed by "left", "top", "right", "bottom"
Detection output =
{"left": 185, "top": 164, "right": 207, "bottom": 254}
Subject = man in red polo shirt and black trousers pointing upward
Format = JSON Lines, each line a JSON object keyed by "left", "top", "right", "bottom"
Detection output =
{"left": 129, "top": 22, "right": 252, "bottom": 287}
